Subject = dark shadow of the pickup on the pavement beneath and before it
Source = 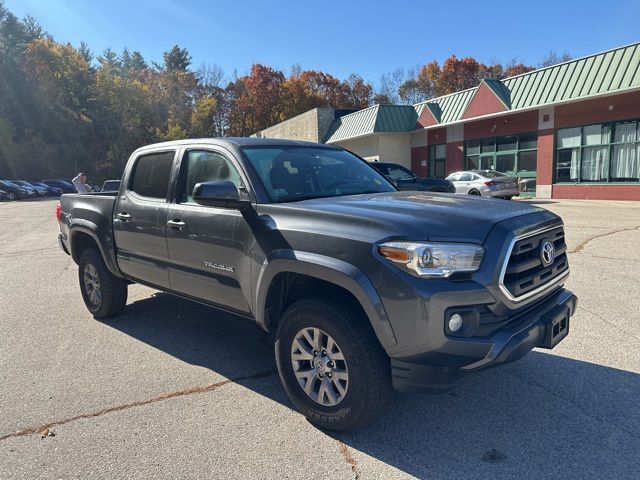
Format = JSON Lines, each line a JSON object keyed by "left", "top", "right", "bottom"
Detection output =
{"left": 104, "top": 293, "right": 640, "bottom": 478}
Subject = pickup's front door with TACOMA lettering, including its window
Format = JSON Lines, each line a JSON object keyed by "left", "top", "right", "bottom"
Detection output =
{"left": 167, "top": 149, "right": 253, "bottom": 313}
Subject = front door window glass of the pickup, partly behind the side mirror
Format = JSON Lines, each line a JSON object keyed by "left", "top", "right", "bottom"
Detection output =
{"left": 178, "top": 150, "right": 242, "bottom": 203}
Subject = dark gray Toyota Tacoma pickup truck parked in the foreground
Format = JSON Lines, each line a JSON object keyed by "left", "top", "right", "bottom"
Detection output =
{"left": 58, "top": 138, "right": 577, "bottom": 430}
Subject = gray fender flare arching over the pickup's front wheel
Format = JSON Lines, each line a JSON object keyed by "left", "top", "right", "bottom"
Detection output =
{"left": 254, "top": 250, "right": 397, "bottom": 348}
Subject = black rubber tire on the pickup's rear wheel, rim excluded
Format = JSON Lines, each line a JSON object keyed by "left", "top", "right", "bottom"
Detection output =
{"left": 78, "top": 248, "right": 128, "bottom": 318}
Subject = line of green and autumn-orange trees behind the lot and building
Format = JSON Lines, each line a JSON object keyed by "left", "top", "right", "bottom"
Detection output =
{"left": 0, "top": 0, "right": 566, "bottom": 181}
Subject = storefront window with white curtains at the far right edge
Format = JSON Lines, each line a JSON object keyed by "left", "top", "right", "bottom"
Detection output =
{"left": 555, "top": 121, "right": 640, "bottom": 183}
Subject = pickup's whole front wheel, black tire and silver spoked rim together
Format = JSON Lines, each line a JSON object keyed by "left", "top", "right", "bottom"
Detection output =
{"left": 275, "top": 299, "right": 391, "bottom": 431}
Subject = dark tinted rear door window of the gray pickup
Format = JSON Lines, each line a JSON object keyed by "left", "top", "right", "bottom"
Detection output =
{"left": 130, "top": 152, "right": 175, "bottom": 199}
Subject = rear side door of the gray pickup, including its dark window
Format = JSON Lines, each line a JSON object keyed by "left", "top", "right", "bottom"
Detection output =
{"left": 113, "top": 149, "right": 176, "bottom": 288}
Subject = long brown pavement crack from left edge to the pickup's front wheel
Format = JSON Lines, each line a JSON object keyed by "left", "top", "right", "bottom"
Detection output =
{"left": 0, "top": 370, "right": 276, "bottom": 441}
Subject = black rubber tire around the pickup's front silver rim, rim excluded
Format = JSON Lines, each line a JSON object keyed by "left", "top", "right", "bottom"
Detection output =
{"left": 275, "top": 299, "right": 392, "bottom": 431}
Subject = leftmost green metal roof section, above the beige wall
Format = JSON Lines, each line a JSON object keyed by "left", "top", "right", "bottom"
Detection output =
{"left": 324, "top": 105, "right": 418, "bottom": 143}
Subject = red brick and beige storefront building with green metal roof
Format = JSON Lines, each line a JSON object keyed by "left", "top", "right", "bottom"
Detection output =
{"left": 252, "top": 43, "right": 640, "bottom": 200}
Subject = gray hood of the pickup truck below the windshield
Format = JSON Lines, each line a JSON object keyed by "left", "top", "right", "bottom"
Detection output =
{"left": 259, "top": 191, "right": 542, "bottom": 243}
